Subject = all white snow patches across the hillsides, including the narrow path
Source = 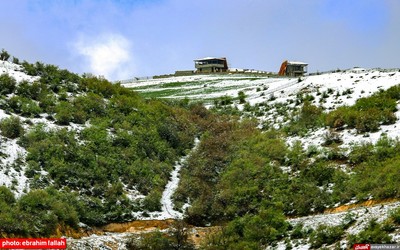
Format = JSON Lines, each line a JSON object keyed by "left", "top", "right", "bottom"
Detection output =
{"left": 4, "top": 58, "right": 400, "bottom": 249}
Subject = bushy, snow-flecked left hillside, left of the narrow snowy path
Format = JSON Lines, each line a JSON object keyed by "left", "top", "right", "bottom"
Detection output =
{"left": 0, "top": 51, "right": 206, "bottom": 236}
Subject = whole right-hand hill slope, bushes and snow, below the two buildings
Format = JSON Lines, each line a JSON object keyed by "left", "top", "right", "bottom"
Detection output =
{"left": 125, "top": 69, "right": 400, "bottom": 248}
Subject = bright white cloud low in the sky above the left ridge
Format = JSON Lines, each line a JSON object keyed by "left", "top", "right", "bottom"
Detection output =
{"left": 74, "top": 34, "right": 134, "bottom": 80}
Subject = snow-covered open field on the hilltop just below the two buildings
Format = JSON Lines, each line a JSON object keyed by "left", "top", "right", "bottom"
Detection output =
{"left": 123, "top": 69, "right": 400, "bottom": 108}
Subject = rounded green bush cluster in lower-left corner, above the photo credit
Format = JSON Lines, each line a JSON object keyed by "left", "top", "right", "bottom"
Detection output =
{"left": 0, "top": 186, "right": 80, "bottom": 237}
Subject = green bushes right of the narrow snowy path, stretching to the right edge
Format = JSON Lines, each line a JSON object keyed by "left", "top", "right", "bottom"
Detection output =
{"left": 176, "top": 113, "right": 400, "bottom": 246}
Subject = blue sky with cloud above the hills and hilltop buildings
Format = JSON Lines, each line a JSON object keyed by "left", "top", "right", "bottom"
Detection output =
{"left": 0, "top": 0, "right": 400, "bottom": 80}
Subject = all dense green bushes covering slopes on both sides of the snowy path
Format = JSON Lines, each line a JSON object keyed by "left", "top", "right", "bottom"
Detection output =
{"left": 0, "top": 52, "right": 400, "bottom": 246}
